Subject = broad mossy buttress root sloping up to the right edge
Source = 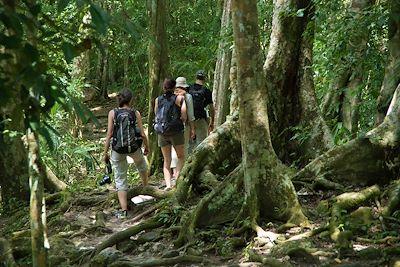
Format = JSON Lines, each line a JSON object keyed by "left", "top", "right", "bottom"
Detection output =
{"left": 293, "top": 84, "right": 400, "bottom": 185}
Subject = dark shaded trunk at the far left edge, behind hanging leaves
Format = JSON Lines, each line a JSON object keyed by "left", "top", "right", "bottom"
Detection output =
{"left": 0, "top": 1, "right": 29, "bottom": 211}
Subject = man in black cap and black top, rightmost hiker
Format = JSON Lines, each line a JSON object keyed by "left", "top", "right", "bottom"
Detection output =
{"left": 189, "top": 70, "right": 214, "bottom": 153}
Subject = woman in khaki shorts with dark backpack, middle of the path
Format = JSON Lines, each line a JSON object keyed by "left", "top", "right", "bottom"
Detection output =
{"left": 154, "top": 79, "right": 187, "bottom": 190}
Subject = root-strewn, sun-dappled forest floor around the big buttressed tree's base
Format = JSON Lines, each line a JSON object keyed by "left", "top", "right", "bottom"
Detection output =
{"left": 1, "top": 95, "right": 400, "bottom": 266}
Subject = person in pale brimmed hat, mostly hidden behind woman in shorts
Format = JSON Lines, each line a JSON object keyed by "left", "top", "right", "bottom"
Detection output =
{"left": 171, "top": 77, "right": 196, "bottom": 183}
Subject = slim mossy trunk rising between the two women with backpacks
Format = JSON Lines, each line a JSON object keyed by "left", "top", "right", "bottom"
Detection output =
{"left": 148, "top": 0, "right": 169, "bottom": 173}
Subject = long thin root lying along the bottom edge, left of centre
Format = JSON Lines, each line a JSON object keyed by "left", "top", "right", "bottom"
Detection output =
{"left": 109, "top": 255, "right": 216, "bottom": 267}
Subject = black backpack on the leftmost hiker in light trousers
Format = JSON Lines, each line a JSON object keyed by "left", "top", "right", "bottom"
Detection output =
{"left": 112, "top": 108, "right": 143, "bottom": 154}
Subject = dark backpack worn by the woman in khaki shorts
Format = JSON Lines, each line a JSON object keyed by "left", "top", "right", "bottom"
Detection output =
{"left": 153, "top": 94, "right": 183, "bottom": 135}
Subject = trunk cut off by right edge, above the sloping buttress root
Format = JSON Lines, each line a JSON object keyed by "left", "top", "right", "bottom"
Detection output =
{"left": 376, "top": 0, "right": 400, "bottom": 125}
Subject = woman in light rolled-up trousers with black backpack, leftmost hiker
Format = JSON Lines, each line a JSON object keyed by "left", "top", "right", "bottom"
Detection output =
{"left": 104, "top": 89, "right": 149, "bottom": 218}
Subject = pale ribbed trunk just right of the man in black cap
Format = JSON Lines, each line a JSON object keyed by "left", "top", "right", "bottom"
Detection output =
{"left": 213, "top": 0, "right": 232, "bottom": 129}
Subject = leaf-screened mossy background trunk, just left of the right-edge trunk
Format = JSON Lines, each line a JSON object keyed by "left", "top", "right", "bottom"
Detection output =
{"left": 322, "top": 0, "right": 376, "bottom": 136}
